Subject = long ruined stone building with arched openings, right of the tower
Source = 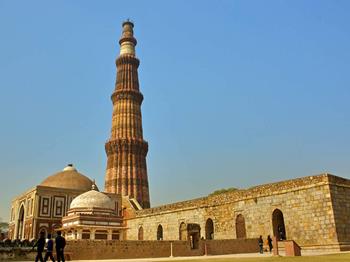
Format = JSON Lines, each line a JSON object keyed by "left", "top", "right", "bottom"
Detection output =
{"left": 126, "top": 174, "right": 350, "bottom": 250}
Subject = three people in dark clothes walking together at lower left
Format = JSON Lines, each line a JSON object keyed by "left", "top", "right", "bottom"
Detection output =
{"left": 33, "top": 231, "right": 66, "bottom": 262}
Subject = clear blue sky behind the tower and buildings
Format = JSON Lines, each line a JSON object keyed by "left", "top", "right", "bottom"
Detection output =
{"left": 0, "top": 0, "right": 350, "bottom": 220}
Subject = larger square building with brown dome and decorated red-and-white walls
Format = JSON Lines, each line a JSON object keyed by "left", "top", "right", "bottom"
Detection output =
{"left": 9, "top": 164, "right": 94, "bottom": 239}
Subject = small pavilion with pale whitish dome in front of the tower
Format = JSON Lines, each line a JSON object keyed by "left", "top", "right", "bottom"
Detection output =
{"left": 60, "top": 185, "right": 126, "bottom": 240}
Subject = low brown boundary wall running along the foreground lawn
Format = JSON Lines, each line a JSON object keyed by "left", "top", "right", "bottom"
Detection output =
{"left": 65, "top": 239, "right": 258, "bottom": 260}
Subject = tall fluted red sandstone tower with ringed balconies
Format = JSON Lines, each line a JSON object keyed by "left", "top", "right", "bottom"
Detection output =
{"left": 105, "top": 21, "right": 150, "bottom": 208}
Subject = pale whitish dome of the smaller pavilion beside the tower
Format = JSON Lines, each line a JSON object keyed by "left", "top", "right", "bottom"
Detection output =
{"left": 70, "top": 185, "right": 114, "bottom": 210}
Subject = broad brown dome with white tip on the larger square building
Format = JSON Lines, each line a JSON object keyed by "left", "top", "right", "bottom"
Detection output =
{"left": 40, "top": 164, "right": 93, "bottom": 191}
